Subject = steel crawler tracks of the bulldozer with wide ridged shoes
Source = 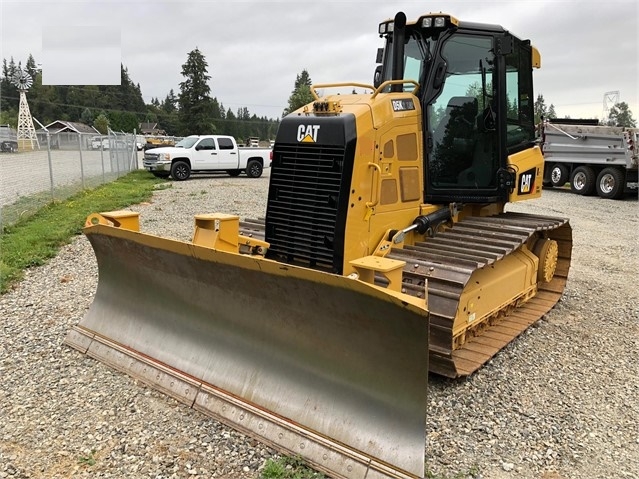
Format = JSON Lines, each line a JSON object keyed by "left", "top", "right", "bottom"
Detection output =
{"left": 240, "top": 213, "right": 572, "bottom": 378}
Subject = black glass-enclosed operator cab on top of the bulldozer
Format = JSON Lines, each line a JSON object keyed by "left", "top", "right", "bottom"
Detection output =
{"left": 374, "top": 13, "right": 539, "bottom": 203}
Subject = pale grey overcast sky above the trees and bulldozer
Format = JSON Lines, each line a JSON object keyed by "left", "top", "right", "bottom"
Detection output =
{"left": 0, "top": 0, "right": 639, "bottom": 119}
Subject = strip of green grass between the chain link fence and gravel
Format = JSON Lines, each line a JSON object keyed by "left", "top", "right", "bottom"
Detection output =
{"left": 0, "top": 171, "right": 169, "bottom": 294}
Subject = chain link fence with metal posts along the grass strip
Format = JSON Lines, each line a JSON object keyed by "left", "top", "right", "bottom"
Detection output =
{"left": 0, "top": 131, "right": 142, "bottom": 232}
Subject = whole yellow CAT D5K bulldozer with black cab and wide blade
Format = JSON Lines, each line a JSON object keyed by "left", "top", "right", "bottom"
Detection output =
{"left": 66, "top": 12, "right": 572, "bottom": 479}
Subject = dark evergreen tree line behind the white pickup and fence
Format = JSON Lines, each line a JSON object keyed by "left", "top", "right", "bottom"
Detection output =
{"left": 0, "top": 48, "right": 279, "bottom": 140}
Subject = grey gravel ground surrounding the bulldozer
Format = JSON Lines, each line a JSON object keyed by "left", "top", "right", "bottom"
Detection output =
{"left": 0, "top": 175, "right": 639, "bottom": 479}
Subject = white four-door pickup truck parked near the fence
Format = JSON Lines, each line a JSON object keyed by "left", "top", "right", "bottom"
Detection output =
{"left": 142, "top": 135, "right": 271, "bottom": 181}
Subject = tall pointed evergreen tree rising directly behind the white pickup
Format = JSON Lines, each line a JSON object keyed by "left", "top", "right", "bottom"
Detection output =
{"left": 178, "top": 47, "right": 213, "bottom": 135}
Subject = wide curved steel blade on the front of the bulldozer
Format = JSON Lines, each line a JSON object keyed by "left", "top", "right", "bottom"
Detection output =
{"left": 65, "top": 224, "right": 428, "bottom": 479}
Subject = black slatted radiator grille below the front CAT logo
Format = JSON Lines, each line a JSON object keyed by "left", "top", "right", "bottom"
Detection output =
{"left": 266, "top": 143, "right": 350, "bottom": 271}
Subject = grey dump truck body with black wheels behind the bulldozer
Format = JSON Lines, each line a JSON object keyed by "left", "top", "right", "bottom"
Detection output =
{"left": 541, "top": 119, "right": 639, "bottom": 200}
